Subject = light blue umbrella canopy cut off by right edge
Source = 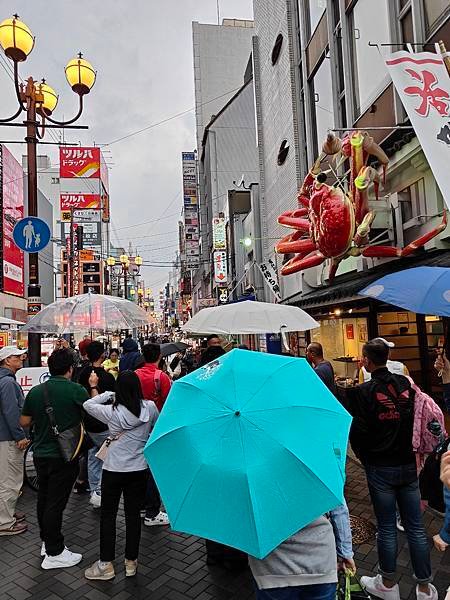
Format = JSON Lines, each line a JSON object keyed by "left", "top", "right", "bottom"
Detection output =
{"left": 359, "top": 267, "right": 450, "bottom": 317}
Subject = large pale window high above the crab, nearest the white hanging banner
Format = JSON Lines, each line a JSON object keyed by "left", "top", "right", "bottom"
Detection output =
{"left": 350, "top": 0, "right": 390, "bottom": 117}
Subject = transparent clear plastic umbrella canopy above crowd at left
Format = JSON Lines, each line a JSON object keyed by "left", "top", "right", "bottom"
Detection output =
{"left": 22, "top": 293, "right": 147, "bottom": 335}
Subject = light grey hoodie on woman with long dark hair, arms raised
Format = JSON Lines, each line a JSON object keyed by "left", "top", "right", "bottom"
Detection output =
{"left": 83, "top": 392, "right": 159, "bottom": 473}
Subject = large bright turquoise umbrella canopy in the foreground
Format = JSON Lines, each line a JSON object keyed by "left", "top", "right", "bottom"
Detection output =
{"left": 144, "top": 350, "right": 351, "bottom": 558}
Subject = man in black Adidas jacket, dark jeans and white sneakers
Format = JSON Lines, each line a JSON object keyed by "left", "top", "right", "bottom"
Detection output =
{"left": 350, "top": 340, "right": 438, "bottom": 600}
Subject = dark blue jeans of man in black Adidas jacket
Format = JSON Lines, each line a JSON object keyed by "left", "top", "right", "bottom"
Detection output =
{"left": 366, "top": 464, "right": 432, "bottom": 583}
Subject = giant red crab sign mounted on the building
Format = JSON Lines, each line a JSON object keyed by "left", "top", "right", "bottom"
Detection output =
{"left": 275, "top": 131, "right": 447, "bottom": 283}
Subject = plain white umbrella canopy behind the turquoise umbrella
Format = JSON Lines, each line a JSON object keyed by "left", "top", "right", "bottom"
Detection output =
{"left": 182, "top": 300, "right": 319, "bottom": 334}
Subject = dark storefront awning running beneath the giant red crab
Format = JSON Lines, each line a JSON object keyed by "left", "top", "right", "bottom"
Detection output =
{"left": 283, "top": 250, "right": 450, "bottom": 308}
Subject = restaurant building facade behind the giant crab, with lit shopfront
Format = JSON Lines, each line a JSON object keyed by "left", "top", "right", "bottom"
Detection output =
{"left": 253, "top": 0, "right": 450, "bottom": 389}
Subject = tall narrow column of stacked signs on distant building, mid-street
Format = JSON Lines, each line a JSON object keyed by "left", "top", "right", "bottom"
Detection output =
{"left": 181, "top": 152, "right": 200, "bottom": 269}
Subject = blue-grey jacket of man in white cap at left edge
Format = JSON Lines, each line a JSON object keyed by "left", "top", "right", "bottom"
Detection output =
{"left": 0, "top": 367, "right": 26, "bottom": 442}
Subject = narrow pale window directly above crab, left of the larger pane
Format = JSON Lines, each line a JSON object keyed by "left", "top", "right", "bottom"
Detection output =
{"left": 311, "top": 58, "right": 334, "bottom": 155}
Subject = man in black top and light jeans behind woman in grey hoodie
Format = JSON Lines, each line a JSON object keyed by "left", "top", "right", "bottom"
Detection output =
{"left": 78, "top": 341, "right": 116, "bottom": 508}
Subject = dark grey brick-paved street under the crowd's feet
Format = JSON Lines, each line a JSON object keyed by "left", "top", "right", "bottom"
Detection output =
{"left": 0, "top": 460, "right": 450, "bottom": 600}
